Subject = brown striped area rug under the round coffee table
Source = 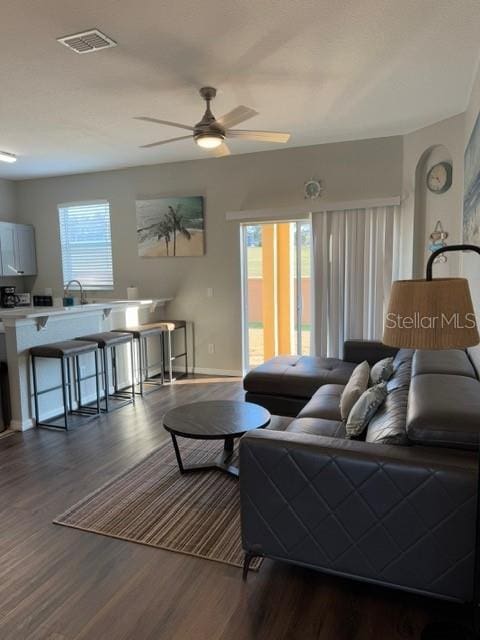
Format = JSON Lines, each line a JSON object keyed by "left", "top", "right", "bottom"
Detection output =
{"left": 54, "top": 438, "right": 261, "bottom": 570}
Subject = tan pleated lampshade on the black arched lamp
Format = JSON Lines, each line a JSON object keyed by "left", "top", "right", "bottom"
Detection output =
{"left": 383, "top": 278, "right": 480, "bottom": 349}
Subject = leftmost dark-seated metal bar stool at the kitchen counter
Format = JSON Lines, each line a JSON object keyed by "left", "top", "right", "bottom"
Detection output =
{"left": 30, "top": 340, "right": 100, "bottom": 430}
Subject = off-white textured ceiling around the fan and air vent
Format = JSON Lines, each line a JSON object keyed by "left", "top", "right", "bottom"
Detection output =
{"left": 0, "top": 0, "right": 480, "bottom": 179}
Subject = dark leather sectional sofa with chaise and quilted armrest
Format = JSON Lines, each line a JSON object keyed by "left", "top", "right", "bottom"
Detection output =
{"left": 240, "top": 341, "right": 480, "bottom": 602}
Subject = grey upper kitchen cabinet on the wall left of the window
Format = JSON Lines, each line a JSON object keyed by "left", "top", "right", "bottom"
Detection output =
{"left": 0, "top": 222, "right": 37, "bottom": 276}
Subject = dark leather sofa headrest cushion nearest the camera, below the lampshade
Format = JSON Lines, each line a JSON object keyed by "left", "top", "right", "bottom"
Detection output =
{"left": 407, "top": 373, "right": 480, "bottom": 449}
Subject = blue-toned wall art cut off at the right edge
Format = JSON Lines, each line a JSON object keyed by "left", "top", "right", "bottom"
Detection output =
{"left": 463, "top": 114, "right": 480, "bottom": 244}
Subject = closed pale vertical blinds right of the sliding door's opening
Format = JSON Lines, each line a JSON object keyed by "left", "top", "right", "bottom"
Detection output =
{"left": 311, "top": 206, "right": 400, "bottom": 357}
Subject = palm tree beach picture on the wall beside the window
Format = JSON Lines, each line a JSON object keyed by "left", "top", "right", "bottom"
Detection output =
{"left": 136, "top": 196, "right": 205, "bottom": 258}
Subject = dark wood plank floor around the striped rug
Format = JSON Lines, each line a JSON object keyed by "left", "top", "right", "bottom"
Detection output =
{"left": 0, "top": 377, "right": 463, "bottom": 640}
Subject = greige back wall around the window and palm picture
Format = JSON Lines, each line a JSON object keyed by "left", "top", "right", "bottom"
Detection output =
{"left": 17, "top": 137, "right": 402, "bottom": 372}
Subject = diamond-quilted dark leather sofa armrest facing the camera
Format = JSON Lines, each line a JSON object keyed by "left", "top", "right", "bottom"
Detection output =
{"left": 240, "top": 430, "right": 477, "bottom": 602}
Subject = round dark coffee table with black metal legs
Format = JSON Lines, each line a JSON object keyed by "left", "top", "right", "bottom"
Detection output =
{"left": 163, "top": 400, "right": 271, "bottom": 477}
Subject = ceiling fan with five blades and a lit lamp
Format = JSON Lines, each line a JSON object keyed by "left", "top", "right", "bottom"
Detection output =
{"left": 135, "top": 87, "right": 290, "bottom": 157}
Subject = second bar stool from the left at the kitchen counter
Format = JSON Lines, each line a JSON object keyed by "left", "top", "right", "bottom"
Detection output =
{"left": 76, "top": 331, "right": 135, "bottom": 413}
